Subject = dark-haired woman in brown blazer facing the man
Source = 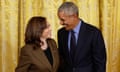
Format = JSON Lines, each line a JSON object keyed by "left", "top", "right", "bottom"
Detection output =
{"left": 15, "top": 17, "right": 59, "bottom": 72}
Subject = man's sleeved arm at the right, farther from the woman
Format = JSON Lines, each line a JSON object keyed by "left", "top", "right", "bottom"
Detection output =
{"left": 93, "top": 30, "right": 106, "bottom": 72}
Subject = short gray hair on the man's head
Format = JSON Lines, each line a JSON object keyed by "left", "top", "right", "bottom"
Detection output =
{"left": 58, "top": 2, "right": 79, "bottom": 15}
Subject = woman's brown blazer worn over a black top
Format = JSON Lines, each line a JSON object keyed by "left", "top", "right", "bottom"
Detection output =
{"left": 15, "top": 39, "right": 59, "bottom": 72}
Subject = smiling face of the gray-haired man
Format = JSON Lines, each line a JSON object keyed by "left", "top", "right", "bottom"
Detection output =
{"left": 58, "top": 11, "right": 75, "bottom": 30}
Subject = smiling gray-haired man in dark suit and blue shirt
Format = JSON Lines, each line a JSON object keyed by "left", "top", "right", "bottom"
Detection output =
{"left": 58, "top": 2, "right": 106, "bottom": 72}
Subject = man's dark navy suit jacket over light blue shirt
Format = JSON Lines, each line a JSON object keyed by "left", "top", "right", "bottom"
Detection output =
{"left": 58, "top": 20, "right": 106, "bottom": 72}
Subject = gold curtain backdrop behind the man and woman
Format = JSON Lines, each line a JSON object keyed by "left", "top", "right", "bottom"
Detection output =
{"left": 0, "top": 0, "right": 120, "bottom": 72}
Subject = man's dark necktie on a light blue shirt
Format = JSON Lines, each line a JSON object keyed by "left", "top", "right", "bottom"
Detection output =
{"left": 70, "top": 30, "right": 76, "bottom": 62}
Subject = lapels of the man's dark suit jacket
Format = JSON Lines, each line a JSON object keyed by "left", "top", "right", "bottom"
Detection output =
{"left": 64, "top": 20, "right": 86, "bottom": 64}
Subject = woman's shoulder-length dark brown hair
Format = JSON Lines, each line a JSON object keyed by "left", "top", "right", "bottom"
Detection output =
{"left": 25, "top": 16, "right": 47, "bottom": 46}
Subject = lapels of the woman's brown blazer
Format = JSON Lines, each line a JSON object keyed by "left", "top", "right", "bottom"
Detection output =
{"left": 32, "top": 41, "right": 56, "bottom": 70}
